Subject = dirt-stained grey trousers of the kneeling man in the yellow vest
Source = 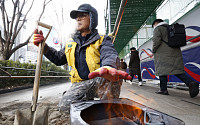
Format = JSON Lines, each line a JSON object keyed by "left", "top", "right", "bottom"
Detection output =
{"left": 58, "top": 77, "right": 122, "bottom": 113}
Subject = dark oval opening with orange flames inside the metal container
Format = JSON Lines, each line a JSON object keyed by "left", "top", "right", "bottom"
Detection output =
{"left": 81, "top": 103, "right": 149, "bottom": 125}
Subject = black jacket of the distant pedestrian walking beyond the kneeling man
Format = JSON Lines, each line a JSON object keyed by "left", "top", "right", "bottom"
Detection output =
{"left": 129, "top": 50, "right": 140, "bottom": 75}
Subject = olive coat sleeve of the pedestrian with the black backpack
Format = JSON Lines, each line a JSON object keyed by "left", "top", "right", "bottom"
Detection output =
{"left": 152, "top": 27, "right": 162, "bottom": 53}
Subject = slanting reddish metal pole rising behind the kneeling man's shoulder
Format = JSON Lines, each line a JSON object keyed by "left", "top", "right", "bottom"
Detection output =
{"left": 112, "top": 0, "right": 128, "bottom": 43}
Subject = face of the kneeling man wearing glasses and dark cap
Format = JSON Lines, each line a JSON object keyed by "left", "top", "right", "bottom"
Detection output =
{"left": 76, "top": 12, "right": 90, "bottom": 32}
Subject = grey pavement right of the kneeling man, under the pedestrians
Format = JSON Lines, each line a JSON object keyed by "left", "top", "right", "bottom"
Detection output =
{"left": 120, "top": 82, "right": 200, "bottom": 125}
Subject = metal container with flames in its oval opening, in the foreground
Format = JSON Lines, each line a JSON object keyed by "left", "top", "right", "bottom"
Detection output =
{"left": 70, "top": 98, "right": 185, "bottom": 125}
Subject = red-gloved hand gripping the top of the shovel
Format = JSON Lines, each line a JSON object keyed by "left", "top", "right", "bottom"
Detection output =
{"left": 33, "top": 29, "right": 44, "bottom": 46}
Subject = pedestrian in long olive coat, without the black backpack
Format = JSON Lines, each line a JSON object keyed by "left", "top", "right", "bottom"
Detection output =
{"left": 152, "top": 19, "right": 199, "bottom": 98}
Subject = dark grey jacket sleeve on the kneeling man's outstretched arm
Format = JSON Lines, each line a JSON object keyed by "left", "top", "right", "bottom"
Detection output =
{"left": 100, "top": 35, "right": 120, "bottom": 69}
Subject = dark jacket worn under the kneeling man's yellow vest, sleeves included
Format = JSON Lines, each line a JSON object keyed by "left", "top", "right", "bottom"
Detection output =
{"left": 45, "top": 30, "right": 120, "bottom": 79}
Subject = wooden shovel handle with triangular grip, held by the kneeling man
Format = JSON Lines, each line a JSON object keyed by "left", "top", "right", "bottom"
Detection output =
{"left": 32, "top": 22, "right": 52, "bottom": 111}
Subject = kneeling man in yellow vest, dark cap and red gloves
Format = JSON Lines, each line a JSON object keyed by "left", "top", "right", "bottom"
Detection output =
{"left": 34, "top": 4, "right": 131, "bottom": 113}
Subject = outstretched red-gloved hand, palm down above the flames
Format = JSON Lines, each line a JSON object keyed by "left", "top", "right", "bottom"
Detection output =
{"left": 88, "top": 66, "right": 131, "bottom": 82}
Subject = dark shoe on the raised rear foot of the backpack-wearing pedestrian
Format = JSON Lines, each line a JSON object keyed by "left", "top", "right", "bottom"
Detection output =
{"left": 189, "top": 82, "right": 199, "bottom": 98}
